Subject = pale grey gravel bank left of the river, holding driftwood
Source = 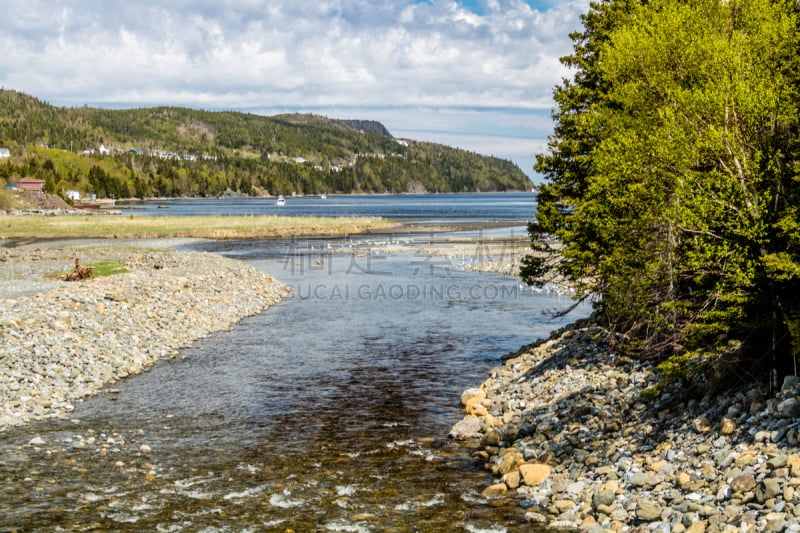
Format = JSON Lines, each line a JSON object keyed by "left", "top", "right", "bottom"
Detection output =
{"left": 0, "top": 247, "right": 289, "bottom": 430}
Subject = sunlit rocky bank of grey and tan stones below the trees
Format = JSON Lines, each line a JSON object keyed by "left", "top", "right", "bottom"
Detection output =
{"left": 450, "top": 324, "right": 800, "bottom": 533}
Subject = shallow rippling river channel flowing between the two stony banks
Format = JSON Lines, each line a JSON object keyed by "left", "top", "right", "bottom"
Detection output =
{"left": 0, "top": 239, "right": 586, "bottom": 532}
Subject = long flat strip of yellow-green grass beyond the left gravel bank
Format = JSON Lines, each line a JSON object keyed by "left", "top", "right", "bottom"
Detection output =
{"left": 0, "top": 215, "right": 397, "bottom": 239}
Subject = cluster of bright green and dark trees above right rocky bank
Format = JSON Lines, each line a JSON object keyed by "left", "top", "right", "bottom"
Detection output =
{"left": 525, "top": 0, "right": 800, "bottom": 390}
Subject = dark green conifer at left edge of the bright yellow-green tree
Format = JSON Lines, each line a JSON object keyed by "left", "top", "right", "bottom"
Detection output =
{"left": 522, "top": 0, "right": 638, "bottom": 298}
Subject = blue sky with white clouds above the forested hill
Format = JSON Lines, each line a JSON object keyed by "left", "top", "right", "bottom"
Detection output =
{"left": 0, "top": 0, "right": 589, "bottom": 182}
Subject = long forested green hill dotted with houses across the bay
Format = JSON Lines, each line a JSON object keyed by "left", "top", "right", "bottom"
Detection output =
{"left": 0, "top": 90, "right": 530, "bottom": 198}
